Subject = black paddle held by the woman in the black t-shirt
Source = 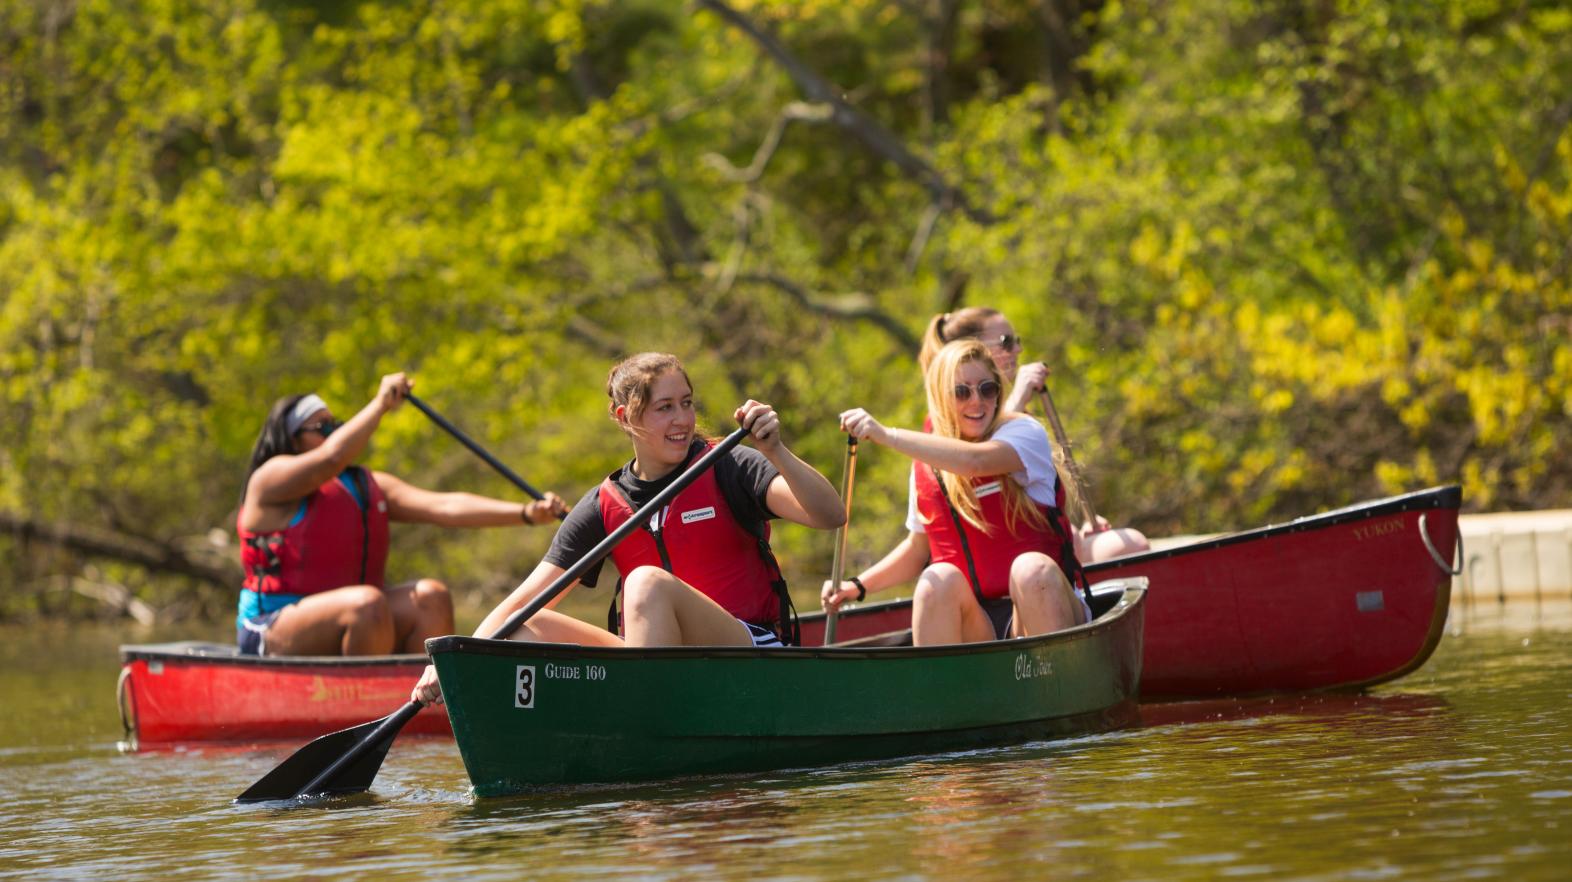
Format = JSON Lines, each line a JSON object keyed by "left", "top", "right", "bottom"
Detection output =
{"left": 234, "top": 429, "right": 748, "bottom": 802}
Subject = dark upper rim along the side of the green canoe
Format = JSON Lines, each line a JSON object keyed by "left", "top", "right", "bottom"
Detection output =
{"left": 426, "top": 575, "right": 1148, "bottom": 660}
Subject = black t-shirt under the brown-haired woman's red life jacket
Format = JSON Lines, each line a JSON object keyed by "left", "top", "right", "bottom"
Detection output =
{"left": 545, "top": 440, "right": 780, "bottom": 588}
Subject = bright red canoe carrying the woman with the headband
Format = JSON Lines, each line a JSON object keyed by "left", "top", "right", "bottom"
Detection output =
{"left": 119, "top": 643, "right": 453, "bottom": 748}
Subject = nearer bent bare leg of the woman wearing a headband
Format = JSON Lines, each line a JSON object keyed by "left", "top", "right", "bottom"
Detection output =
{"left": 266, "top": 585, "right": 393, "bottom": 656}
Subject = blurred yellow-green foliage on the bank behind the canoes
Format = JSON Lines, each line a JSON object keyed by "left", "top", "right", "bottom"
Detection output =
{"left": 0, "top": 0, "right": 1572, "bottom": 615}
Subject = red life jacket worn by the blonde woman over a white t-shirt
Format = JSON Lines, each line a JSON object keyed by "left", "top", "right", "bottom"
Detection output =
{"left": 912, "top": 462, "right": 1080, "bottom": 597}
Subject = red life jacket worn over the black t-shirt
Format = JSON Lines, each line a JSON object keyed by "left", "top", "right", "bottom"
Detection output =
{"left": 601, "top": 445, "right": 789, "bottom": 632}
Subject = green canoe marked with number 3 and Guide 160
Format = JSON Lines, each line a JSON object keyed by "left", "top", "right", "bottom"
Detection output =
{"left": 426, "top": 577, "right": 1146, "bottom": 797}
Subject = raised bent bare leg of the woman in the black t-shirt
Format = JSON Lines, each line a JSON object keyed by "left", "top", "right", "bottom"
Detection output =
{"left": 623, "top": 566, "right": 753, "bottom": 646}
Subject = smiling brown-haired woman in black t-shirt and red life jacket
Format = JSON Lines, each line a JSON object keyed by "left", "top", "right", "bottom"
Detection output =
{"left": 410, "top": 352, "right": 846, "bottom": 703}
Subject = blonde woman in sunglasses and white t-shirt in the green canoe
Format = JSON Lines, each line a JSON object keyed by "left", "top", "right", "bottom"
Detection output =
{"left": 821, "top": 340, "right": 1091, "bottom": 646}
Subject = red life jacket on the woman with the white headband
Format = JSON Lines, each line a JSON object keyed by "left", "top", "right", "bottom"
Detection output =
{"left": 236, "top": 465, "right": 388, "bottom": 594}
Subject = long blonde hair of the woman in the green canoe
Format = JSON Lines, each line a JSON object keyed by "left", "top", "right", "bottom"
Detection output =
{"left": 924, "top": 340, "right": 1049, "bottom": 533}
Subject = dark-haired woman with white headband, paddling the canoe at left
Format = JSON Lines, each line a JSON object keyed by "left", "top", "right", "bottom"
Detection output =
{"left": 236, "top": 373, "right": 566, "bottom": 656}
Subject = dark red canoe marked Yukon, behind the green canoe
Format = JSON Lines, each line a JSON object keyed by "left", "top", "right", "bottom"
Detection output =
{"left": 802, "top": 486, "right": 1462, "bottom": 700}
